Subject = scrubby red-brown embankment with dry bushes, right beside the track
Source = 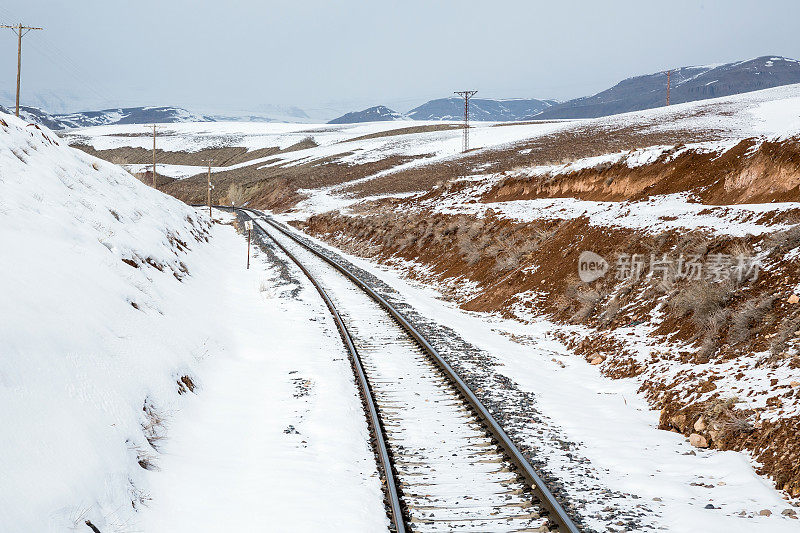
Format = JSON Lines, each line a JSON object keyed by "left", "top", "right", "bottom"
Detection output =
{"left": 301, "top": 200, "right": 800, "bottom": 496}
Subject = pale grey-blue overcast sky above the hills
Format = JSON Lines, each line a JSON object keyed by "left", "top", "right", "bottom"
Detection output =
{"left": 0, "top": 0, "right": 800, "bottom": 119}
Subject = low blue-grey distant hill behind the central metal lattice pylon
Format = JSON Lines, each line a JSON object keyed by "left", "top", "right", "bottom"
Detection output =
{"left": 407, "top": 97, "right": 556, "bottom": 121}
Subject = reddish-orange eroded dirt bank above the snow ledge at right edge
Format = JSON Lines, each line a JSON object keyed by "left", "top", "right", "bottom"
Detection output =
{"left": 483, "top": 139, "right": 800, "bottom": 205}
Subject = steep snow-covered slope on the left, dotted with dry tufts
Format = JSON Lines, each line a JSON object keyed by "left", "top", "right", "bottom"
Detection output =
{"left": 0, "top": 110, "right": 208, "bottom": 533}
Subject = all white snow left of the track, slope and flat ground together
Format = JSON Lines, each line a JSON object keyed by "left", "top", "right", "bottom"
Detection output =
{"left": 0, "top": 114, "right": 386, "bottom": 533}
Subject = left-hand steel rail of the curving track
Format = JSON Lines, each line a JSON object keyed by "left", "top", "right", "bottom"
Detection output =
{"left": 237, "top": 209, "right": 406, "bottom": 533}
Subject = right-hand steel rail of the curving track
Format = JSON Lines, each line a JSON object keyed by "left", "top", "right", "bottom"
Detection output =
{"left": 242, "top": 209, "right": 579, "bottom": 533}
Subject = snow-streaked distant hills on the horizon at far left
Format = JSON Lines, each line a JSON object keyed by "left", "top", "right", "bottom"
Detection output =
{"left": 0, "top": 106, "right": 213, "bottom": 130}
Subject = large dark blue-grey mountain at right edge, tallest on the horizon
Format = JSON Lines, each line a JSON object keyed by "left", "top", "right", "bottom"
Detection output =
{"left": 536, "top": 56, "right": 800, "bottom": 119}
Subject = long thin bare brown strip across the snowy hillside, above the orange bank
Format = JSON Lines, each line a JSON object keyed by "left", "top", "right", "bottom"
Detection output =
{"left": 345, "top": 122, "right": 719, "bottom": 197}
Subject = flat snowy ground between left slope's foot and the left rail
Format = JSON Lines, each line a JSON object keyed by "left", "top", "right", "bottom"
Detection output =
{"left": 141, "top": 214, "right": 388, "bottom": 533}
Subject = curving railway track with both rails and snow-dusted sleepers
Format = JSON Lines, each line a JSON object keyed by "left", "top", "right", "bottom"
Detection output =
{"left": 238, "top": 209, "right": 578, "bottom": 533}
